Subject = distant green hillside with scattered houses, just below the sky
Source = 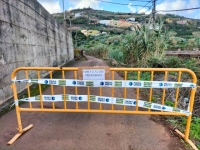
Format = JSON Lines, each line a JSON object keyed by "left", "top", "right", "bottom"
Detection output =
{"left": 53, "top": 8, "right": 200, "bottom": 38}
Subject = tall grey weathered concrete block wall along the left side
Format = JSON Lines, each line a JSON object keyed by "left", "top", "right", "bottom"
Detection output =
{"left": 0, "top": 0, "right": 74, "bottom": 105}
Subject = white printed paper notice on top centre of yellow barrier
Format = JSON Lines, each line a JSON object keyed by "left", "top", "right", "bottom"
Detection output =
{"left": 82, "top": 69, "right": 105, "bottom": 80}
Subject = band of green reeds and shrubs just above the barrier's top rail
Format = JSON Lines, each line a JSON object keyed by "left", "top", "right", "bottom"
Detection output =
{"left": 76, "top": 23, "right": 200, "bottom": 71}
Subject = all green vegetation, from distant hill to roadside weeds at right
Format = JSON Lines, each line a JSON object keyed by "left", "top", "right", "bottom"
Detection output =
{"left": 52, "top": 8, "right": 200, "bottom": 148}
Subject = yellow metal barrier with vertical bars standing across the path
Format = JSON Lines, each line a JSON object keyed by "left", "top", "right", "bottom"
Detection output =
{"left": 8, "top": 67, "right": 197, "bottom": 149}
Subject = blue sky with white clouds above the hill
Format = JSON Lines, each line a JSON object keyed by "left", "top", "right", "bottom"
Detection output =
{"left": 38, "top": 0, "right": 200, "bottom": 19}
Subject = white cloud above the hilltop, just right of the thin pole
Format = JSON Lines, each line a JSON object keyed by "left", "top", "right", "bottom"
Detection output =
{"left": 69, "top": 0, "right": 102, "bottom": 9}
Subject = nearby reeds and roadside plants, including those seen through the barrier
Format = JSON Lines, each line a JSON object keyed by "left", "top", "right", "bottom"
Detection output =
{"left": 72, "top": 18, "right": 200, "bottom": 146}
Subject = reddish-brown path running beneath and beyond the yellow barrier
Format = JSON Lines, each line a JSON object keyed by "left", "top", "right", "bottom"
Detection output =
{"left": 0, "top": 56, "right": 188, "bottom": 150}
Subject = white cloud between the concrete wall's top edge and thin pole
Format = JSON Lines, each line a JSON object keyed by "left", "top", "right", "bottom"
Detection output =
{"left": 38, "top": 0, "right": 62, "bottom": 14}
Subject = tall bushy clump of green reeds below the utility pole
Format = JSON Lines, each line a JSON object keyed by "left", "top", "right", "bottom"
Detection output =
{"left": 121, "top": 24, "right": 169, "bottom": 66}
